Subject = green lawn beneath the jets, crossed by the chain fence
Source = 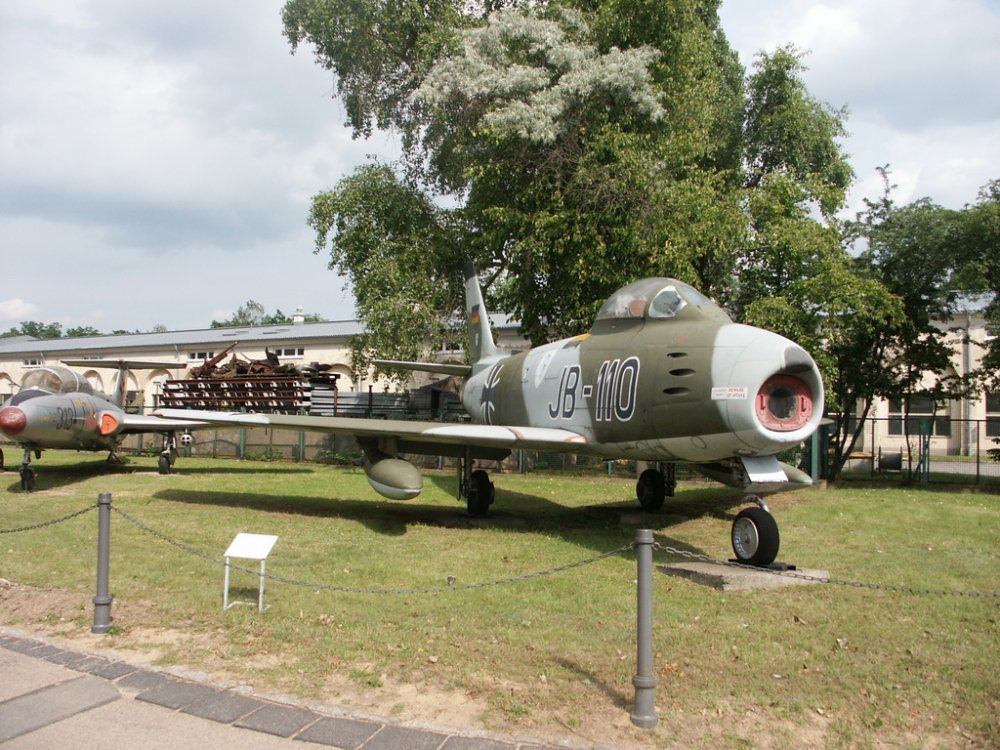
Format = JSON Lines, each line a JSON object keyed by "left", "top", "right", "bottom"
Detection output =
{"left": 0, "top": 452, "right": 1000, "bottom": 748}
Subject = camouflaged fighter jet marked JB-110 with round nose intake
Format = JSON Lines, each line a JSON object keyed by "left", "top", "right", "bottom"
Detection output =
{"left": 156, "top": 264, "right": 823, "bottom": 565}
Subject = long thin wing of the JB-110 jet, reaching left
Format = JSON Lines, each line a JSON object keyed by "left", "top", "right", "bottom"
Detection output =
{"left": 153, "top": 409, "right": 587, "bottom": 455}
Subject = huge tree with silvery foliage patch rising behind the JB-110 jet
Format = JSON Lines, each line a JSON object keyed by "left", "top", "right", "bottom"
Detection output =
{"left": 285, "top": 0, "right": 744, "bottom": 356}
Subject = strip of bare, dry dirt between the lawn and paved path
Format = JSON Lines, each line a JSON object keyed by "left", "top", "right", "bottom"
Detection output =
{"left": 0, "top": 579, "right": 983, "bottom": 750}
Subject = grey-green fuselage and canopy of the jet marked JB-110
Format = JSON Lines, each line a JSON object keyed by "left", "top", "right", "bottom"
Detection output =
{"left": 463, "top": 278, "right": 823, "bottom": 463}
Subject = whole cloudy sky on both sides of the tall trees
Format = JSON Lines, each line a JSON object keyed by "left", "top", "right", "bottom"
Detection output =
{"left": 0, "top": 0, "right": 1000, "bottom": 331}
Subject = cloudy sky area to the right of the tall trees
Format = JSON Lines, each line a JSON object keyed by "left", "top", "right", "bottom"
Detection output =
{"left": 721, "top": 0, "right": 1000, "bottom": 214}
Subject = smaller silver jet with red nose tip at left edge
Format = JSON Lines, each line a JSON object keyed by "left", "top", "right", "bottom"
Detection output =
{"left": 0, "top": 359, "right": 207, "bottom": 491}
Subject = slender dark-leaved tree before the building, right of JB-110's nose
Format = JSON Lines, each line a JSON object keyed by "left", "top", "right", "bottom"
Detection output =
{"left": 812, "top": 167, "right": 969, "bottom": 478}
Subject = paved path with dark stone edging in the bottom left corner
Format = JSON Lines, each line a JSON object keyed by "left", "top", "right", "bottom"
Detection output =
{"left": 0, "top": 629, "right": 581, "bottom": 750}
